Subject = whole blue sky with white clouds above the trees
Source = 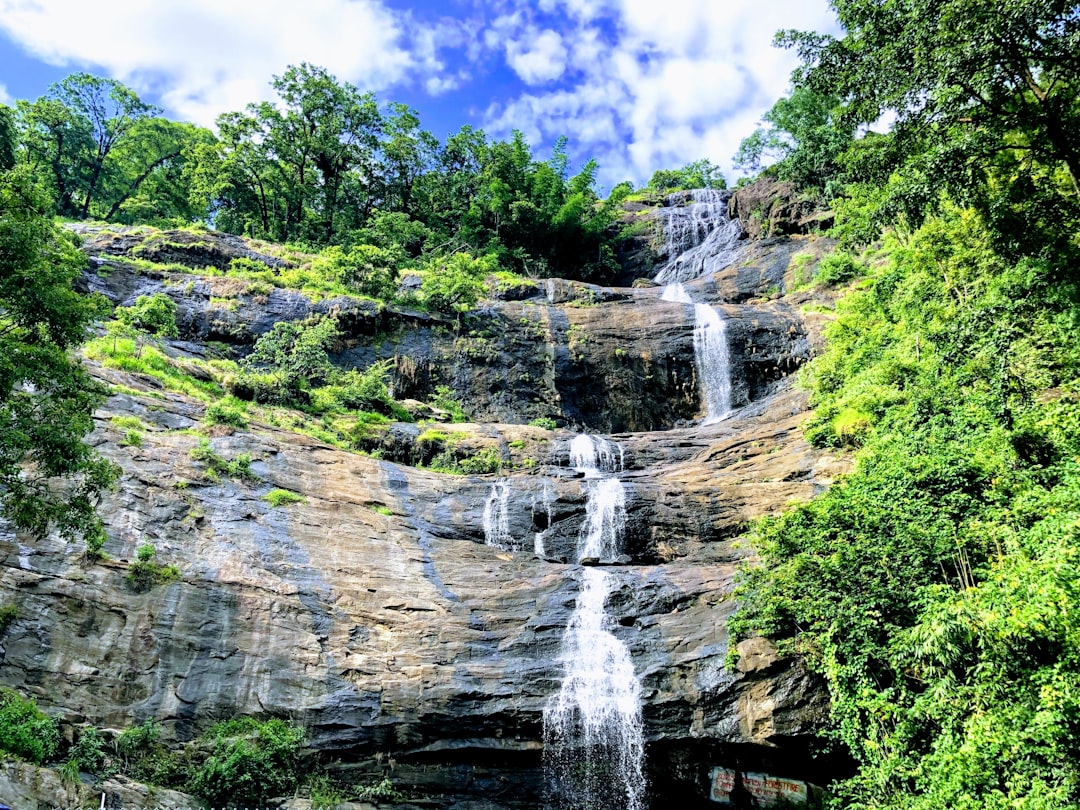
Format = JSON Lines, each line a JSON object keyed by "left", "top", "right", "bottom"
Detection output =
{"left": 0, "top": 0, "right": 836, "bottom": 188}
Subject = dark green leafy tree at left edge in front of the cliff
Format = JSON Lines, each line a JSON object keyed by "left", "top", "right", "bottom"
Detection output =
{"left": 0, "top": 160, "right": 116, "bottom": 551}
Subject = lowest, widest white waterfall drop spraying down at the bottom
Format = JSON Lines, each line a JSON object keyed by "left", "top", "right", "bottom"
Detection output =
{"left": 543, "top": 568, "right": 645, "bottom": 810}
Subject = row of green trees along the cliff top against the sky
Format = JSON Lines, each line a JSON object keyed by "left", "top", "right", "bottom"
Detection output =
{"left": 3, "top": 64, "right": 724, "bottom": 282}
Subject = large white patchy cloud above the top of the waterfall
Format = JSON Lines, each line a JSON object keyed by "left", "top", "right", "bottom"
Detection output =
{"left": 485, "top": 0, "right": 835, "bottom": 185}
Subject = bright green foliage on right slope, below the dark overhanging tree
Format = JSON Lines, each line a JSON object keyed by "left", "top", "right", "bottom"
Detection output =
{"left": 731, "top": 204, "right": 1080, "bottom": 810}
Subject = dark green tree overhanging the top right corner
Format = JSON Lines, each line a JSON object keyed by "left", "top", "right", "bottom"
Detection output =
{"left": 778, "top": 0, "right": 1080, "bottom": 228}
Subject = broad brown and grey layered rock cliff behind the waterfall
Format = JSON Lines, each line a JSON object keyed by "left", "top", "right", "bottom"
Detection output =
{"left": 0, "top": 193, "right": 843, "bottom": 809}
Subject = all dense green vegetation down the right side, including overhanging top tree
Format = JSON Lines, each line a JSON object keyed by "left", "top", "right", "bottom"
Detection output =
{"left": 733, "top": 0, "right": 1080, "bottom": 810}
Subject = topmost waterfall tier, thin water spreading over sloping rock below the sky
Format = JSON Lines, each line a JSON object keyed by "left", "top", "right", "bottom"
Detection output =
{"left": 653, "top": 189, "right": 742, "bottom": 284}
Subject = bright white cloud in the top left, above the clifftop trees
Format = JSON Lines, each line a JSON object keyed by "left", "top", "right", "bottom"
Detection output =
{"left": 0, "top": 0, "right": 427, "bottom": 124}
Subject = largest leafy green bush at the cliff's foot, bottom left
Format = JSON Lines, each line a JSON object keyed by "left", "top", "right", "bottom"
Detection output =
{"left": 189, "top": 717, "right": 303, "bottom": 807}
